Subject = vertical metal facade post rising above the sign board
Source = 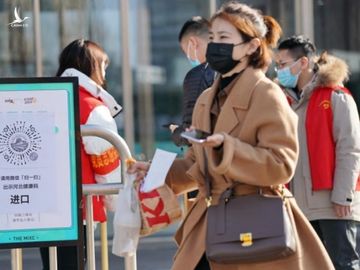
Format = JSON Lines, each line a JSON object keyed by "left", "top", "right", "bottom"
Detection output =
{"left": 33, "top": 0, "right": 43, "bottom": 77}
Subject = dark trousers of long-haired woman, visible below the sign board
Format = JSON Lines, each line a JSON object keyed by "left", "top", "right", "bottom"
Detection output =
{"left": 40, "top": 226, "right": 86, "bottom": 270}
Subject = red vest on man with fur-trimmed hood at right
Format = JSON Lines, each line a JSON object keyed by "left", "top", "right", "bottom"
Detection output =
{"left": 305, "top": 86, "right": 360, "bottom": 191}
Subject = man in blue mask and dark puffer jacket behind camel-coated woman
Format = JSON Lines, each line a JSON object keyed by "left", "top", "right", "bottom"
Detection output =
{"left": 169, "top": 16, "right": 215, "bottom": 146}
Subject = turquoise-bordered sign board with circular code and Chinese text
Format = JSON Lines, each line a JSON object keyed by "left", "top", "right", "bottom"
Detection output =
{"left": 0, "top": 78, "right": 82, "bottom": 248}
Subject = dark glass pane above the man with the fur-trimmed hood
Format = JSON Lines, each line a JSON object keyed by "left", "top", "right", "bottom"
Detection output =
{"left": 314, "top": 0, "right": 360, "bottom": 110}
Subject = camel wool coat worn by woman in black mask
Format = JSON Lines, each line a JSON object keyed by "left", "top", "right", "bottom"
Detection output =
{"left": 166, "top": 67, "right": 334, "bottom": 270}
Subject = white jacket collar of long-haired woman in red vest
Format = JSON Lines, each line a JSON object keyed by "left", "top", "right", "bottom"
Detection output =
{"left": 61, "top": 68, "right": 122, "bottom": 117}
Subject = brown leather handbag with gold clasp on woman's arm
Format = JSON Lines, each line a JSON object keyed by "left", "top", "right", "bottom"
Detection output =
{"left": 205, "top": 155, "right": 296, "bottom": 264}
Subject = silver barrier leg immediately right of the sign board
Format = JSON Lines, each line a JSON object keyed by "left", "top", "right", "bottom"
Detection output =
{"left": 86, "top": 195, "right": 96, "bottom": 270}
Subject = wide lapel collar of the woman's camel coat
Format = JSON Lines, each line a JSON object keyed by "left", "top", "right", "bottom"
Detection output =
{"left": 199, "top": 67, "right": 265, "bottom": 133}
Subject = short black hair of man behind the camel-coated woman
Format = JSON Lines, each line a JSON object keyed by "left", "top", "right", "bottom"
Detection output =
{"left": 179, "top": 16, "right": 210, "bottom": 42}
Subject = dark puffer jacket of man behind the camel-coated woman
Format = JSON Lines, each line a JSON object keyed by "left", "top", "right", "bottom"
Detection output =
{"left": 171, "top": 63, "right": 215, "bottom": 146}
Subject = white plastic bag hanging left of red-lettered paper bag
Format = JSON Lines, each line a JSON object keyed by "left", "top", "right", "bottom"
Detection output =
{"left": 112, "top": 174, "right": 141, "bottom": 257}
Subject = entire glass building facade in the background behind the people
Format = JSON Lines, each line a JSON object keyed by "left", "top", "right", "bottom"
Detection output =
{"left": 0, "top": 0, "right": 360, "bottom": 156}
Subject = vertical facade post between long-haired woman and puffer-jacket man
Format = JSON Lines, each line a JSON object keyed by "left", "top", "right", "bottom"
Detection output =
{"left": 120, "top": 0, "right": 135, "bottom": 150}
